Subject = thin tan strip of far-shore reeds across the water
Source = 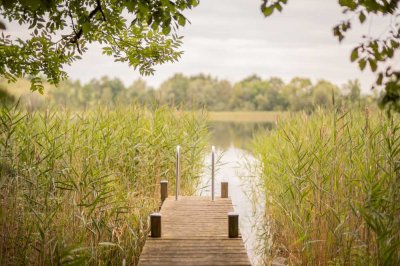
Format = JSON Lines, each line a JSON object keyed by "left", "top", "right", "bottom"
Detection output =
{"left": 209, "top": 111, "right": 287, "bottom": 123}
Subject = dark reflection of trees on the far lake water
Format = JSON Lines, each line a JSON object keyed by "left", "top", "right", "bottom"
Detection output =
{"left": 209, "top": 122, "right": 275, "bottom": 150}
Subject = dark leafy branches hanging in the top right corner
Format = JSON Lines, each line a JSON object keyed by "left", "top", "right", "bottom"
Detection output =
{"left": 261, "top": 0, "right": 400, "bottom": 112}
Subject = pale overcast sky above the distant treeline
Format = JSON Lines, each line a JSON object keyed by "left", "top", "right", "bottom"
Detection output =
{"left": 6, "top": 0, "right": 389, "bottom": 91}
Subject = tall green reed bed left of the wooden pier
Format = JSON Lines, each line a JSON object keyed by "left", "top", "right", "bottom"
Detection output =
{"left": 0, "top": 106, "right": 207, "bottom": 265}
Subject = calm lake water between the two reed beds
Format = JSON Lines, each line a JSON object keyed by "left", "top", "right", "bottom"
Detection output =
{"left": 199, "top": 122, "right": 272, "bottom": 265}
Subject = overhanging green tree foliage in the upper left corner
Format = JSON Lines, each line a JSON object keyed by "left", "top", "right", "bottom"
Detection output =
{"left": 0, "top": 0, "right": 198, "bottom": 92}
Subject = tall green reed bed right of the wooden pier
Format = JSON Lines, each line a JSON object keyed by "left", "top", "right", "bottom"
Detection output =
{"left": 253, "top": 110, "right": 400, "bottom": 265}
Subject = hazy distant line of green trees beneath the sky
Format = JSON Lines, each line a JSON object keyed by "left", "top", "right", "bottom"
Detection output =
{"left": 2, "top": 74, "right": 376, "bottom": 111}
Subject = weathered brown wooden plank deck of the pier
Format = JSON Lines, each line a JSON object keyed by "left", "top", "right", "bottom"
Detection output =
{"left": 139, "top": 196, "right": 251, "bottom": 266}
